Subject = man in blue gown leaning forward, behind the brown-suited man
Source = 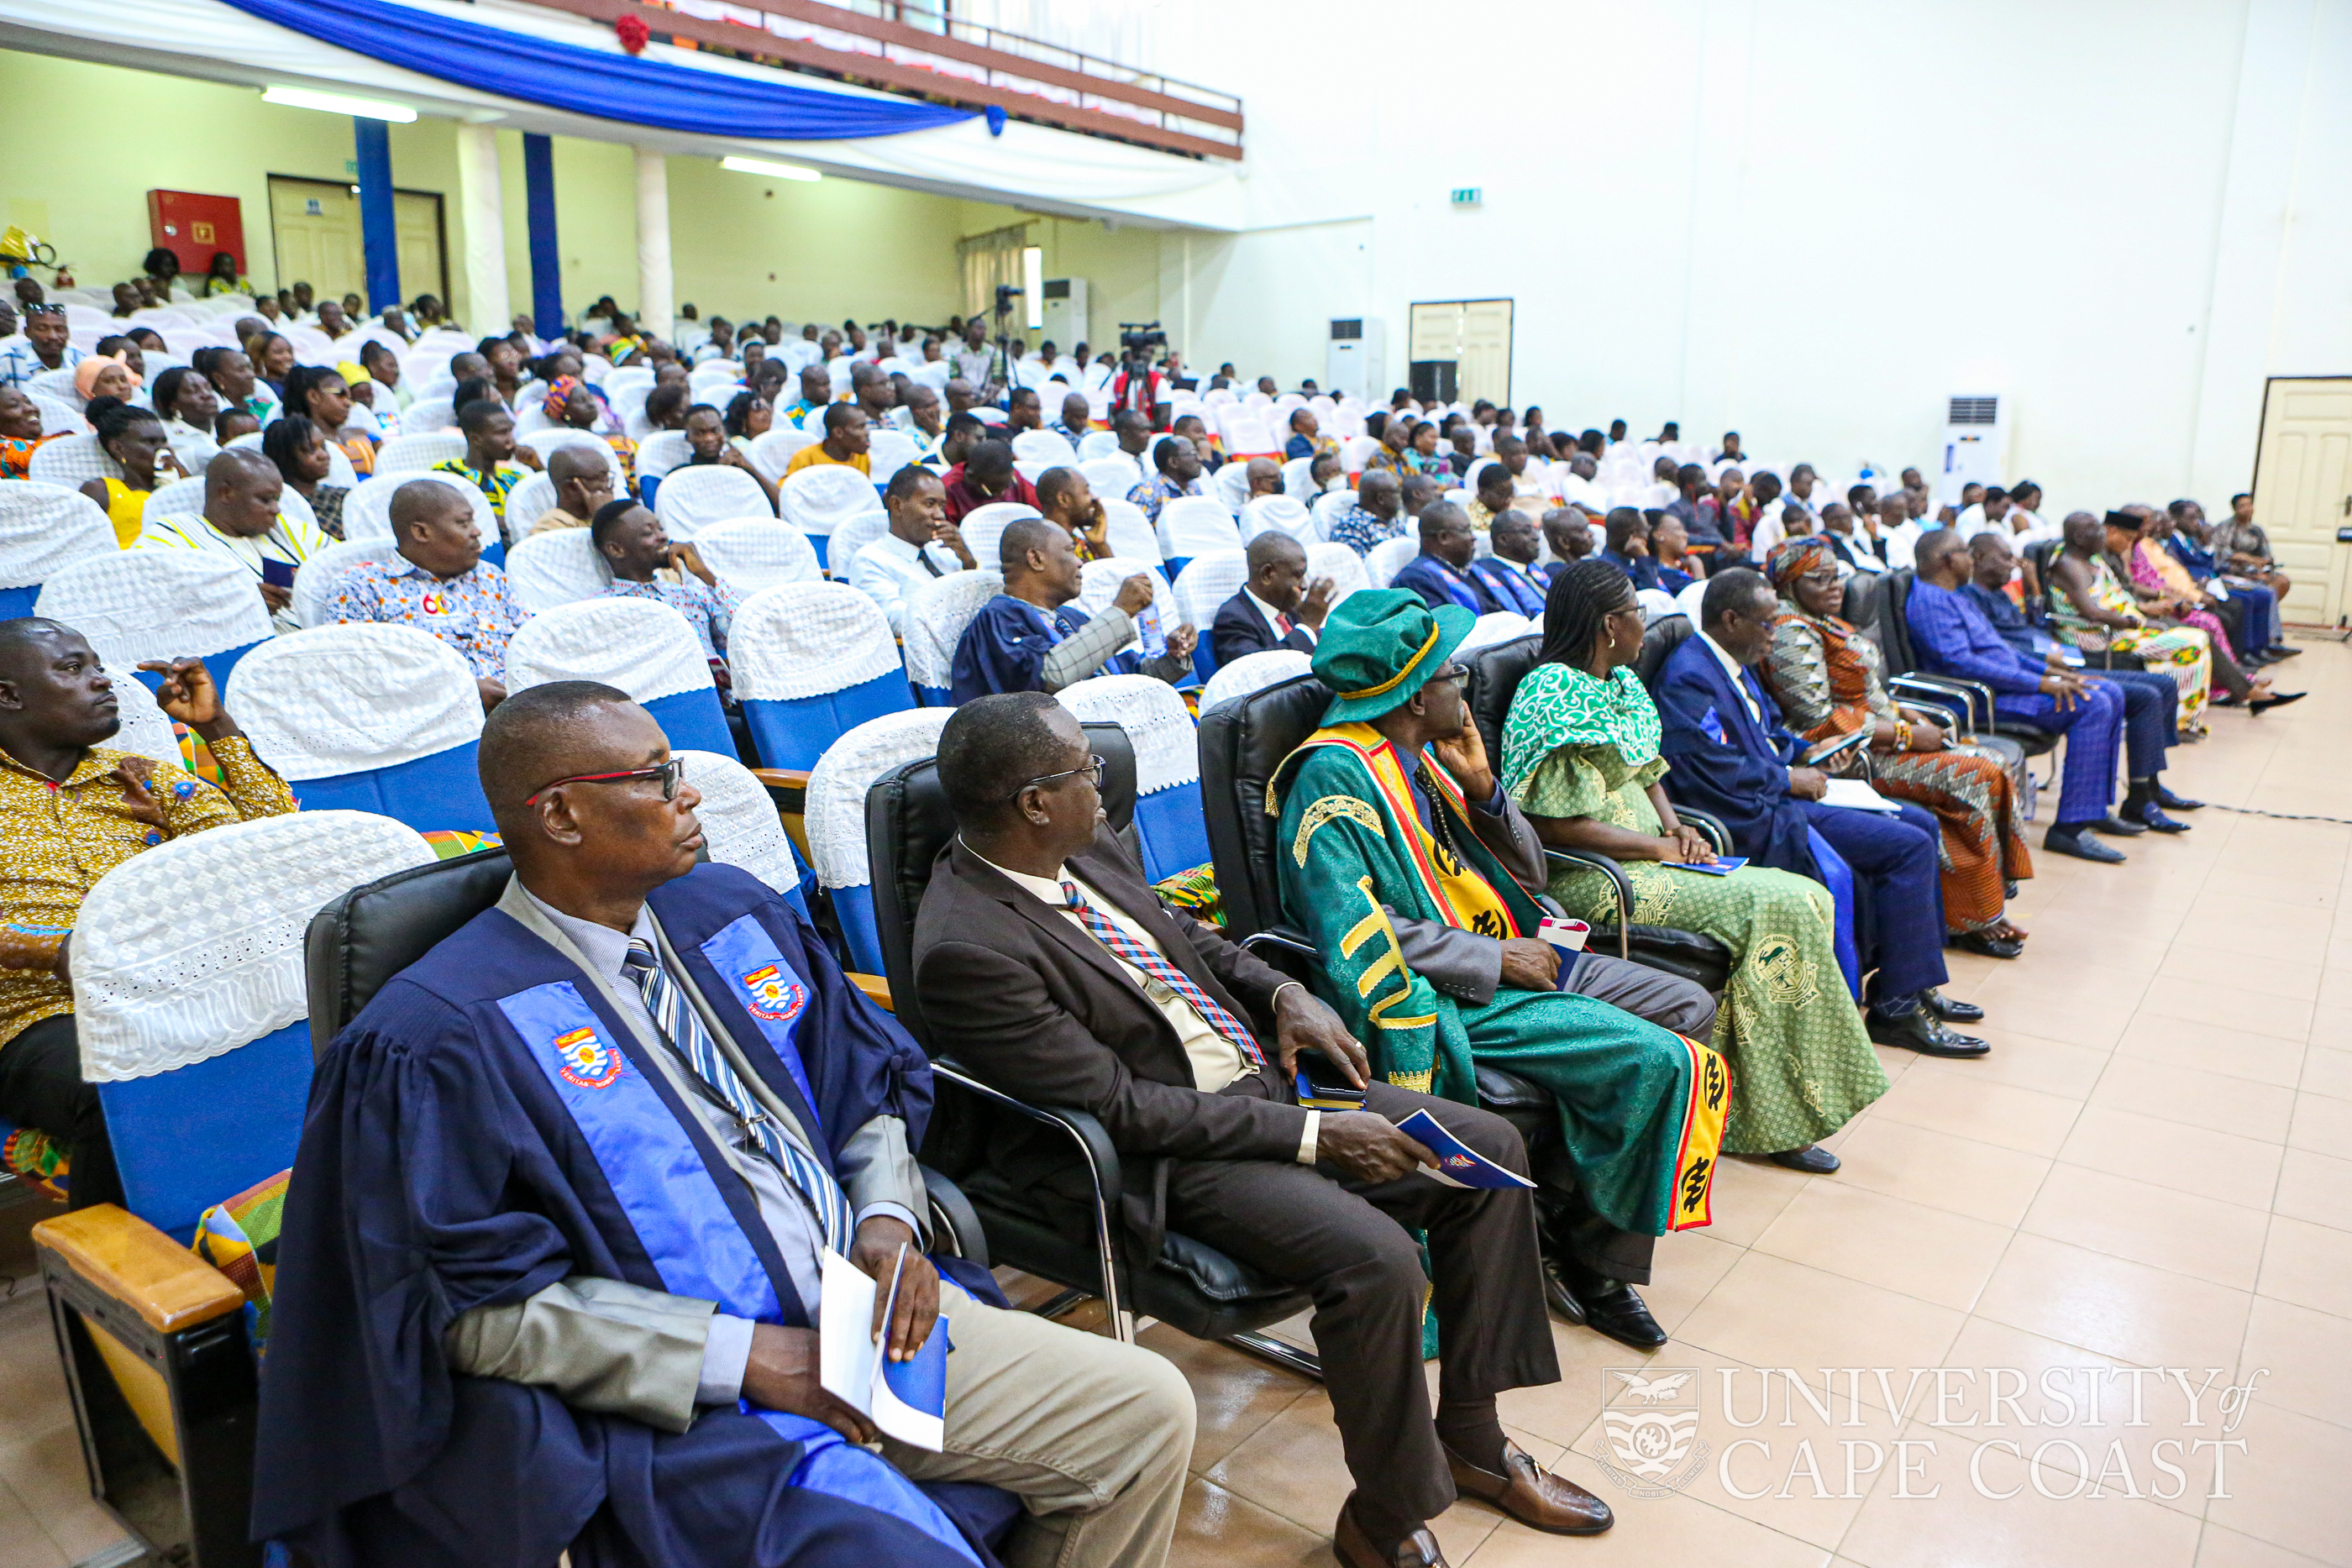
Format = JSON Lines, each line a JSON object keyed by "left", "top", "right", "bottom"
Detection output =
{"left": 953, "top": 517, "right": 1197, "bottom": 703}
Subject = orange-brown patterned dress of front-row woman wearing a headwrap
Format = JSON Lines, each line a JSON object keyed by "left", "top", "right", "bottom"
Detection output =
{"left": 1761, "top": 600, "right": 2034, "bottom": 931}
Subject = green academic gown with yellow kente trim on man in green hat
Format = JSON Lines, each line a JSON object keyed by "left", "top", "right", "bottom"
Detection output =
{"left": 1265, "top": 724, "right": 1731, "bottom": 1236}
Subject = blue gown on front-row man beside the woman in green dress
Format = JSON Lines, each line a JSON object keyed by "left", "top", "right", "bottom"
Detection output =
{"left": 1651, "top": 637, "right": 1945, "bottom": 999}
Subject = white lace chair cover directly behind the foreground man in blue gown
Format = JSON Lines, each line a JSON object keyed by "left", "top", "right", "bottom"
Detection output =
{"left": 73, "top": 811, "right": 433, "bottom": 1083}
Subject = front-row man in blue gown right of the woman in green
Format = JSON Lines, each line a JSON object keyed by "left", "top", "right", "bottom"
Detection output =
{"left": 1653, "top": 567, "right": 1990, "bottom": 1056}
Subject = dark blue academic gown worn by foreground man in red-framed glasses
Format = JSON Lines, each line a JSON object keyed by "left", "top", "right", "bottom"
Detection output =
{"left": 254, "top": 865, "right": 1006, "bottom": 1568}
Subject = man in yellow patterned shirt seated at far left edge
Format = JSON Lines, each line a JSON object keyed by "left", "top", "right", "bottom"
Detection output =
{"left": 0, "top": 616, "right": 294, "bottom": 1209}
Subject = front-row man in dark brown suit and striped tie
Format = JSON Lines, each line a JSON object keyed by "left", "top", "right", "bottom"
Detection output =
{"left": 915, "top": 691, "right": 1611, "bottom": 1568}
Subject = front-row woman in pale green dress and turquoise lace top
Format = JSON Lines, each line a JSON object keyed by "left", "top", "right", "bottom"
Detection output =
{"left": 1503, "top": 559, "right": 1887, "bottom": 1171}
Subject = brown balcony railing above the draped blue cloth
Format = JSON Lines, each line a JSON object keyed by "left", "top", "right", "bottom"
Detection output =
{"left": 532, "top": 0, "right": 1242, "bottom": 158}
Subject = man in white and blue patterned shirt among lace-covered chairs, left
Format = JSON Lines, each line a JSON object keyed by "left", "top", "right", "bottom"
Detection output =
{"left": 329, "top": 480, "right": 532, "bottom": 710}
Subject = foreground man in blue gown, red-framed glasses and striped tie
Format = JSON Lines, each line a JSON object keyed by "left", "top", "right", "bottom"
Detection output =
{"left": 254, "top": 682, "right": 1193, "bottom": 1568}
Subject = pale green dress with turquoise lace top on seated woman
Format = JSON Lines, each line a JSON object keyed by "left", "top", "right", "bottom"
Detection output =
{"left": 1503, "top": 665, "right": 1887, "bottom": 1154}
